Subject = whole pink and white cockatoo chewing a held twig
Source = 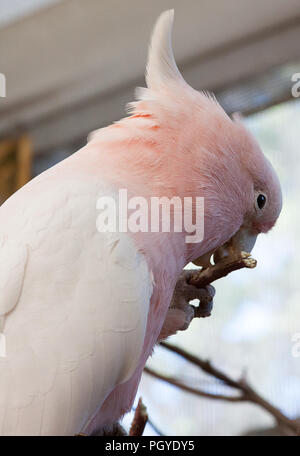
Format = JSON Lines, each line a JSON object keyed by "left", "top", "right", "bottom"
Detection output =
{"left": 0, "top": 11, "right": 281, "bottom": 435}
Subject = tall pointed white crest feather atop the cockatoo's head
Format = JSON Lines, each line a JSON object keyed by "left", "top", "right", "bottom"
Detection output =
{"left": 146, "top": 10, "right": 185, "bottom": 90}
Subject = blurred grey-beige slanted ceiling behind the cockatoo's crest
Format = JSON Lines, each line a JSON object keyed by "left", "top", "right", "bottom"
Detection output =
{"left": 0, "top": 0, "right": 300, "bottom": 151}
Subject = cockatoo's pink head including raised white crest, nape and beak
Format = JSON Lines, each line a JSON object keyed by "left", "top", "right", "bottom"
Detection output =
{"left": 93, "top": 10, "right": 281, "bottom": 266}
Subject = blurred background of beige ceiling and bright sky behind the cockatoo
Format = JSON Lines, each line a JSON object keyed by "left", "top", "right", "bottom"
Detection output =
{"left": 0, "top": 0, "right": 300, "bottom": 435}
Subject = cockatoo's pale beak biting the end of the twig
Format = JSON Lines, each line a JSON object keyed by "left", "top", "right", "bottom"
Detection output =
{"left": 193, "top": 225, "right": 257, "bottom": 268}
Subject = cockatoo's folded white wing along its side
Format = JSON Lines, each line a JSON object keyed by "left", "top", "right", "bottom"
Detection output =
{"left": 0, "top": 172, "right": 152, "bottom": 435}
